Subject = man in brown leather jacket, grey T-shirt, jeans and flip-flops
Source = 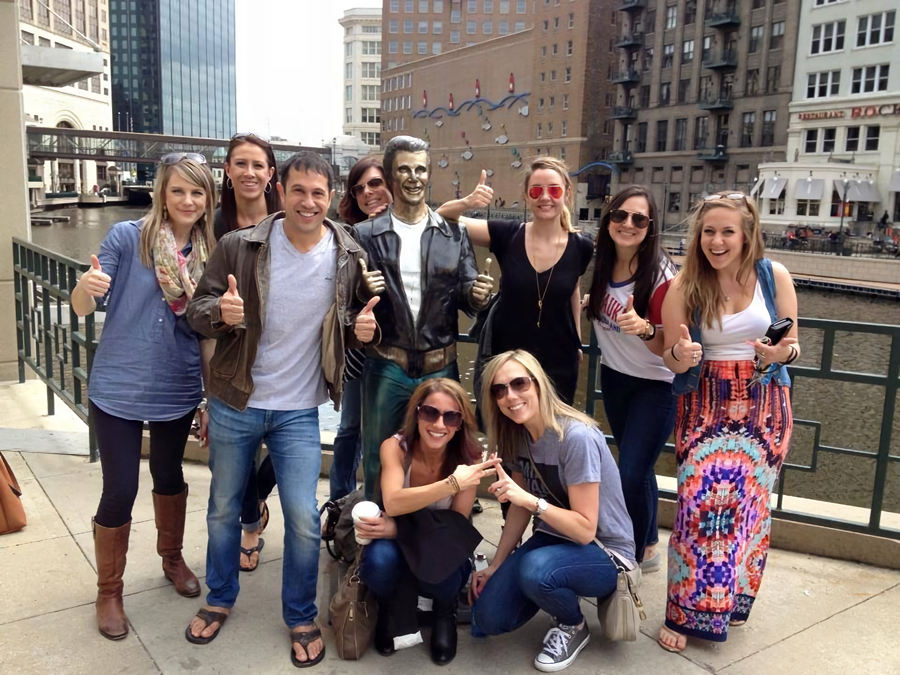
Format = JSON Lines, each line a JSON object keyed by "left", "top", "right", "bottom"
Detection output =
{"left": 185, "top": 152, "right": 378, "bottom": 665}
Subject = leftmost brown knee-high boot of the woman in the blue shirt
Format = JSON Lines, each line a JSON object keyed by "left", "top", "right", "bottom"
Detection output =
{"left": 93, "top": 520, "right": 131, "bottom": 640}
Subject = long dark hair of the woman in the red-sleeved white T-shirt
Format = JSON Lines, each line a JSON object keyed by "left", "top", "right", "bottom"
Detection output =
{"left": 588, "top": 185, "right": 671, "bottom": 321}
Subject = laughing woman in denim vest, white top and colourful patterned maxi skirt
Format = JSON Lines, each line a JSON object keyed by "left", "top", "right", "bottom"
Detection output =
{"left": 659, "top": 193, "right": 800, "bottom": 652}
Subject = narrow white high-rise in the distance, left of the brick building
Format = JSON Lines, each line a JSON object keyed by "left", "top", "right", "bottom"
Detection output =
{"left": 339, "top": 8, "right": 381, "bottom": 146}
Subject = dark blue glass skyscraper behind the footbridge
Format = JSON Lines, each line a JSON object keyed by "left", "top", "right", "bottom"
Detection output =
{"left": 109, "top": 0, "right": 237, "bottom": 138}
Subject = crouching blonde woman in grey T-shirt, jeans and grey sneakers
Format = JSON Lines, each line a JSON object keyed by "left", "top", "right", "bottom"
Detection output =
{"left": 472, "top": 350, "right": 637, "bottom": 672}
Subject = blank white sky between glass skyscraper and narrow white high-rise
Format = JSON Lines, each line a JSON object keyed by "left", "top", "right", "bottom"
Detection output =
{"left": 236, "top": 0, "right": 381, "bottom": 145}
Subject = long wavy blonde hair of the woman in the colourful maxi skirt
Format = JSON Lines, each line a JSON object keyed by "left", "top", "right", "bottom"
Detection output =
{"left": 677, "top": 191, "right": 765, "bottom": 328}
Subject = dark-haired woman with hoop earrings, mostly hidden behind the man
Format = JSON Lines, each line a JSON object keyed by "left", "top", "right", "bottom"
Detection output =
{"left": 214, "top": 133, "right": 281, "bottom": 572}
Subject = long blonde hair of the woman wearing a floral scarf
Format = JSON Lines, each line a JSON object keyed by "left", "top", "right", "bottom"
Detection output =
{"left": 141, "top": 157, "right": 216, "bottom": 268}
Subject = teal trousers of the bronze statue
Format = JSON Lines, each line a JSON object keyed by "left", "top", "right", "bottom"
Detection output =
{"left": 363, "top": 356, "right": 459, "bottom": 499}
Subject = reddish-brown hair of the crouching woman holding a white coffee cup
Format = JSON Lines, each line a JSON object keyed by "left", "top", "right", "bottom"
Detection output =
{"left": 403, "top": 377, "right": 481, "bottom": 479}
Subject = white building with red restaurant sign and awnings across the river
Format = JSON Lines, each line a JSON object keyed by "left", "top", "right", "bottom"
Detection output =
{"left": 757, "top": 0, "right": 900, "bottom": 235}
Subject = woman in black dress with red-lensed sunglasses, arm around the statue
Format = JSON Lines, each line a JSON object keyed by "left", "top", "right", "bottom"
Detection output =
{"left": 438, "top": 157, "right": 594, "bottom": 405}
